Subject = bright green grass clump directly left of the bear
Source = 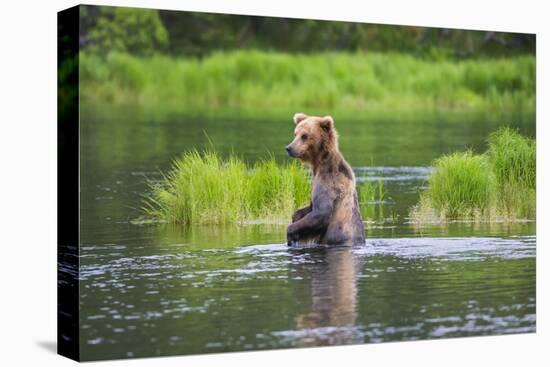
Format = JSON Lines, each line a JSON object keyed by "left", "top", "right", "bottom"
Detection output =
{"left": 144, "top": 150, "right": 311, "bottom": 224}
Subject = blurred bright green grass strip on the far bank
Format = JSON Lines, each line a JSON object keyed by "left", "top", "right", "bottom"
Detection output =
{"left": 80, "top": 51, "right": 535, "bottom": 117}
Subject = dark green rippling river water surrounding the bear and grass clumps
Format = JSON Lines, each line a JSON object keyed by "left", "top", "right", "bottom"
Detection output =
{"left": 76, "top": 106, "right": 536, "bottom": 360}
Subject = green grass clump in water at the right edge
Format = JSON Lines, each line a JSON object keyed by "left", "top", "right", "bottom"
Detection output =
{"left": 411, "top": 128, "right": 536, "bottom": 222}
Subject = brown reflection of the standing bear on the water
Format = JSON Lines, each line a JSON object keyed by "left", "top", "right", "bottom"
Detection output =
{"left": 291, "top": 246, "right": 363, "bottom": 346}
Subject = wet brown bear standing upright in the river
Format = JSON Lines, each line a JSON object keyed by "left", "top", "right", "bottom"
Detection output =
{"left": 286, "top": 113, "right": 365, "bottom": 246}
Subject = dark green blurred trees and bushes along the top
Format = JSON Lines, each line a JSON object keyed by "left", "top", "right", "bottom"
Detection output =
{"left": 80, "top": 6, "right": 535, "bottom": 59}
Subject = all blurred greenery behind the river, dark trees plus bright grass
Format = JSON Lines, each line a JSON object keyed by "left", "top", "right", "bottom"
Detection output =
{"left": 69, "top": 5, "right": 536, "bottom": 121}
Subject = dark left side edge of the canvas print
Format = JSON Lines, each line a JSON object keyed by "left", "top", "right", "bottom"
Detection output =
{"left": 57, "top": 6, "right": 80, "bottom": 360}
